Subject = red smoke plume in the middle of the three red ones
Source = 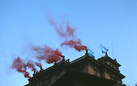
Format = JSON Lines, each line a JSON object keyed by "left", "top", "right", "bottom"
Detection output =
{"left": 32, "top": 45, "right": 63, "bottom": 64}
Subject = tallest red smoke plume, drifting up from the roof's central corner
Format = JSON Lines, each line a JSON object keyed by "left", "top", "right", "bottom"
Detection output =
{"left": 49, "top": 19, "right": 87, "bottom": 51}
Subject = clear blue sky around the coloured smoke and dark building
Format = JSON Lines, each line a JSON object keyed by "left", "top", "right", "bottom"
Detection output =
{"left": 0, "top": 0, "right": 137, "bottom": 86}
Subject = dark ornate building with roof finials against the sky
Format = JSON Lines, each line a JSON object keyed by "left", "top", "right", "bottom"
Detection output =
{"left": 25, "top": 51, "right": 125, "bottom": 86}
